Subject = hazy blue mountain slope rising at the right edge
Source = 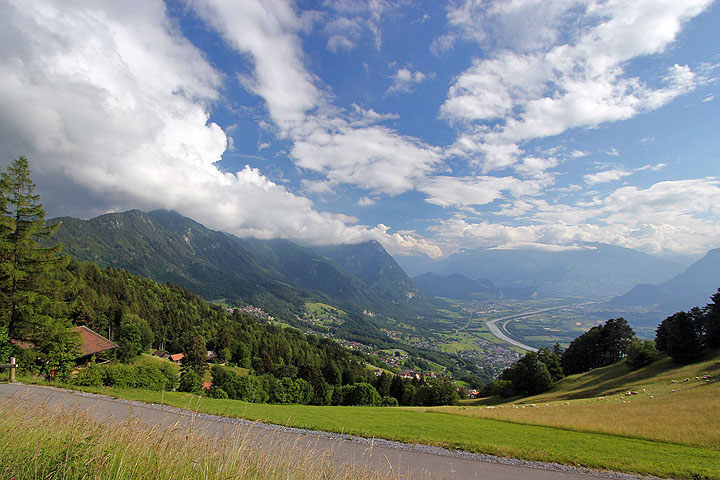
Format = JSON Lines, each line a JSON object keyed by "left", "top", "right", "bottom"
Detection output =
{"left": 608, "top": 248, "right": 720, "bottom": 318}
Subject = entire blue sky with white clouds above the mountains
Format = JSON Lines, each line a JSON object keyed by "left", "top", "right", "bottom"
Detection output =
{"left": 0, "top": 0, "right": 720, "bottom": 258}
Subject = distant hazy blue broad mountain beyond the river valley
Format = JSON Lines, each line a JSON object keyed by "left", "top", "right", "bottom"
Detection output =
{"left": 400, "top": 243, "right": 683, "bottom": 298}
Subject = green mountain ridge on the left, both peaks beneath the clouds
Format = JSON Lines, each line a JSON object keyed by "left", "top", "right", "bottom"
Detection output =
{"left": 51, "top": 210, "right": 428, "bottom": 322}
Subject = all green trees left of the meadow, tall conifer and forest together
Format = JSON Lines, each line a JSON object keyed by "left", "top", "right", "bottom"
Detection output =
{"left": 0, "top": 157, "right": 464, "bottom": 405}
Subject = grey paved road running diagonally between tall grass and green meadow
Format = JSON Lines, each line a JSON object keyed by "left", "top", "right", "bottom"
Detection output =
{"left": 0, "top": 383, "right": 630, "bottom": 480}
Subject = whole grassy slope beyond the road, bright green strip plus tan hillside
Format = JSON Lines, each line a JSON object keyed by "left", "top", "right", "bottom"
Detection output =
{"left": 9, "top": 353, "right": 720, "bottom": 479}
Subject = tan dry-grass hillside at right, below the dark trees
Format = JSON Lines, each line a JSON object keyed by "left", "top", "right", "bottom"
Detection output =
{"left": 438, "top": 350, "right": 720, "bottom": 449}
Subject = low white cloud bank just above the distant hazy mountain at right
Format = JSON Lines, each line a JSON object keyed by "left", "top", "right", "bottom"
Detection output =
{"left": 430, "top": 178, "right": 720, "bottom": 253}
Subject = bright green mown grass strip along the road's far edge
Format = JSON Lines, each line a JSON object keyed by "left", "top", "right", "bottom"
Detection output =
{"left": 33, "top": 380, "right": 720, "bottom": 479}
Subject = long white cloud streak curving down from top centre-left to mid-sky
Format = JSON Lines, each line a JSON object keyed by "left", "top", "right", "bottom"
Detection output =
{"left": 197, "top": 0, "right": 442, "bottom": 195}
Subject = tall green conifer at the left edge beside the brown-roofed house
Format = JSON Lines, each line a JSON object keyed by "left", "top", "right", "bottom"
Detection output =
{"left": 0, "top": 156, "right": 70, "bottom": 341}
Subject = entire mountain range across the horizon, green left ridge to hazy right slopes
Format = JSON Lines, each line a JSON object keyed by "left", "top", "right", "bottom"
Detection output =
{"left": 50, "top": 210, "right": 720, "bottom": 335}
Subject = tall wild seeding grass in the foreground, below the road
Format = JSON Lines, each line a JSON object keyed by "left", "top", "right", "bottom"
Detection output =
{"left": 0, "top": 399, "right": 400, "bottom": 480}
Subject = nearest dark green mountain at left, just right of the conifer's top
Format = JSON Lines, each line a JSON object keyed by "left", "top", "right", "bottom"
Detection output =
{"left": 50, "top": 210, "right": 281, "bottom": 304}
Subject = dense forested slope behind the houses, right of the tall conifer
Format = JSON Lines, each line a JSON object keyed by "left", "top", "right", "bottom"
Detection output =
{"left": 67, "top": 261, "right": 376, "bottom": 379}
